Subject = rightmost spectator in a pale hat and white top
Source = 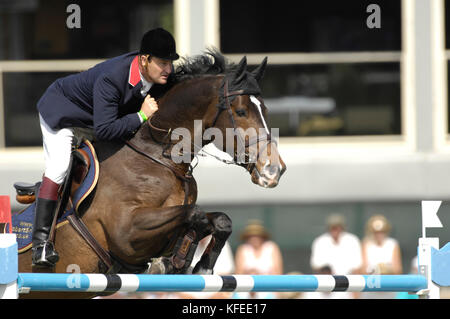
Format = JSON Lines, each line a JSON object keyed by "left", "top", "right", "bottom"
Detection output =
{"left": 362, "top": 215, "right": 403, "bottom": 299}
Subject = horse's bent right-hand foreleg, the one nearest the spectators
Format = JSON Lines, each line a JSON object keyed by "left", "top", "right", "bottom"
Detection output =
{"left": 192, "top": 212, "right": 232, "bottom": 274}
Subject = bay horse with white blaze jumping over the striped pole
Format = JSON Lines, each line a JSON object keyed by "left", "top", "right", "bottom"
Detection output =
{"left": 19, "top": 50, "right": 286, "bottom": 298}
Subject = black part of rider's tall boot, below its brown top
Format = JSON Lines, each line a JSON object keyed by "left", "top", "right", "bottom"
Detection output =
{"left": 32, "top": 197, "right": 59, "bottom": 267}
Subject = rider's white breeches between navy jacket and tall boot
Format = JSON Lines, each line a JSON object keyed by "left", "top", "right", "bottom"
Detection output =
{"left": 39, "top": 114, "right": 74, "bottom": 184}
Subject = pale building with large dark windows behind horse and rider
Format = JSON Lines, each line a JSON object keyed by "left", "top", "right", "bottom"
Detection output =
{"left": 0, "top": 0, "right": 450, "bottom": 273}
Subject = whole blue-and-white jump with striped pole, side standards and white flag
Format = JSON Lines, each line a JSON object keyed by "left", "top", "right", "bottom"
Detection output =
{"left": 0, "top": 201, "right": 450, "bottom": 299}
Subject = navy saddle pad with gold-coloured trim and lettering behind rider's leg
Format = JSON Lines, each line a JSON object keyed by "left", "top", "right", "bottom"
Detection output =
{"left": 12, "top": 140, "right": 99, "bottom": 253}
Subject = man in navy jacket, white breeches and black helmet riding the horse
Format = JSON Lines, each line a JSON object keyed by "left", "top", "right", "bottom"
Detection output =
{"left": 32, "top": 28, "right": 179, "bottom": 267}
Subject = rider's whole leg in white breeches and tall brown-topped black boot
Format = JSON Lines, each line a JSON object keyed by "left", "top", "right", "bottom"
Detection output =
{"left": 32, "top": 116, "right": 73, "bottom": 266}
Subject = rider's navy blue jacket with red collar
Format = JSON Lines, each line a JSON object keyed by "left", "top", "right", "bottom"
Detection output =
{"left": 37, "top": 52, "right": 148, "bottom": 140}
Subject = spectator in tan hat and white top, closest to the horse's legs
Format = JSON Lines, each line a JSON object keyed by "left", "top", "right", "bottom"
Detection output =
{"left": 233, "top": 220, "right": 283, "bottom": 299}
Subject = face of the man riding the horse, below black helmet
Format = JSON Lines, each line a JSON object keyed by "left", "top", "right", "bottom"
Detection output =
{"left": 139, "top": 55, "right": 173, "bottom": 84}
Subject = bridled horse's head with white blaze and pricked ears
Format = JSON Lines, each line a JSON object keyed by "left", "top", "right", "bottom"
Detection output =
{"left": 209, "top": 57, "right": 286, "bottom": 188}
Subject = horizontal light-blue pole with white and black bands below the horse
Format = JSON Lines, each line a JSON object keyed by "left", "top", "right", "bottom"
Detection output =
{"left": 18, "top": 273, "right": 427, "bottom": 292}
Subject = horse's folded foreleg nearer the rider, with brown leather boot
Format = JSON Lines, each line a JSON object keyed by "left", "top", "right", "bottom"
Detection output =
{"left": 150, "top": 207, "right": 214, "bottom": 274}
